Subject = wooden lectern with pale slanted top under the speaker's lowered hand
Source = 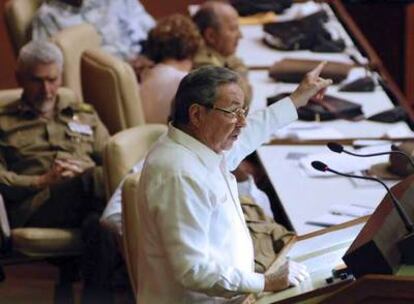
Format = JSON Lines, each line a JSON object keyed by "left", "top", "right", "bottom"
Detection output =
{"left": 243, "top": 218, "right": 414, "bottom": 304}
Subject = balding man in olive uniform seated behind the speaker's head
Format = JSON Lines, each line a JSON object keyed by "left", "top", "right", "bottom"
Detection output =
{"left": 193, "top": 1, "right": 251, "bottom": 102}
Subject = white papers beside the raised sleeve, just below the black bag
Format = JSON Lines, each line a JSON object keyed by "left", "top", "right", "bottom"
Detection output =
{"left": 275, "top": 121, "right": 344, "bottom": 140}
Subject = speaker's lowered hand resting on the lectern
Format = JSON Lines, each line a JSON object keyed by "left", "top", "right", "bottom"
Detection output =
{"left": 264, "top": 261, "right": 309, "bottom": 291}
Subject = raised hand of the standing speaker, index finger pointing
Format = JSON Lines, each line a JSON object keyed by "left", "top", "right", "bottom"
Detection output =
{"left": 290, "top": 61, "right": 332, "bottom": 108}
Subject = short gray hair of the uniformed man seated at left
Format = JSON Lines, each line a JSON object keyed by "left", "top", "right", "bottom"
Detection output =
{"left": 17, "top": 40, "right": 63, "bottom": 71}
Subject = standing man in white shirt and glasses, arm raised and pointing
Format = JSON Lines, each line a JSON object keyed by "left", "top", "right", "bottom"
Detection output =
{"left": 137, "top": 64, "right": 331, "bottom": 304}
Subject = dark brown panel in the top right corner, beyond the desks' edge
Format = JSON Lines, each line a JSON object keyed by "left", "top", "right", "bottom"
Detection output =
{"left": 342, "top": 0, "right": 414, "bottom": 108}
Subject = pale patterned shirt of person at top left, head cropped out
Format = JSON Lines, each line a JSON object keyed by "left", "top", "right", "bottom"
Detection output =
{"left": 32, "top": 0, "right": 155, "bottom": 60}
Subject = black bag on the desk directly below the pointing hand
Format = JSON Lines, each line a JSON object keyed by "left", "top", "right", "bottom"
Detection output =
{"left": 267, "top": 93, "right": 363, "bottom": 121}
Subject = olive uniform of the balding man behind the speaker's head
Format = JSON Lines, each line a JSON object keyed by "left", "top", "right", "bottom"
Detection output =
{"left": 193, "top": 46, "right": 252, "bottom": 104}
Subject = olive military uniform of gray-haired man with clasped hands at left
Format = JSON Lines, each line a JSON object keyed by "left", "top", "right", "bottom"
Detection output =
{"left": 0, "top": 95, "right": 109, "bottom": 227}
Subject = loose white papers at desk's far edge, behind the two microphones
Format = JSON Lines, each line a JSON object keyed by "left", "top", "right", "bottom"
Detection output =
{"left": 299, "top": 145, "right": 391, "bottom": 177}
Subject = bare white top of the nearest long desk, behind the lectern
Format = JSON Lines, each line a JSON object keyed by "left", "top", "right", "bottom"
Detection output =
{"left": 257, "top": 145, "right": 395, "bottom": 235}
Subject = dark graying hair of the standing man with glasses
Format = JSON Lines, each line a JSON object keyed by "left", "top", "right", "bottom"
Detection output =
{"left": 171, "top": 66, "right": 240, "bottom": 127}
